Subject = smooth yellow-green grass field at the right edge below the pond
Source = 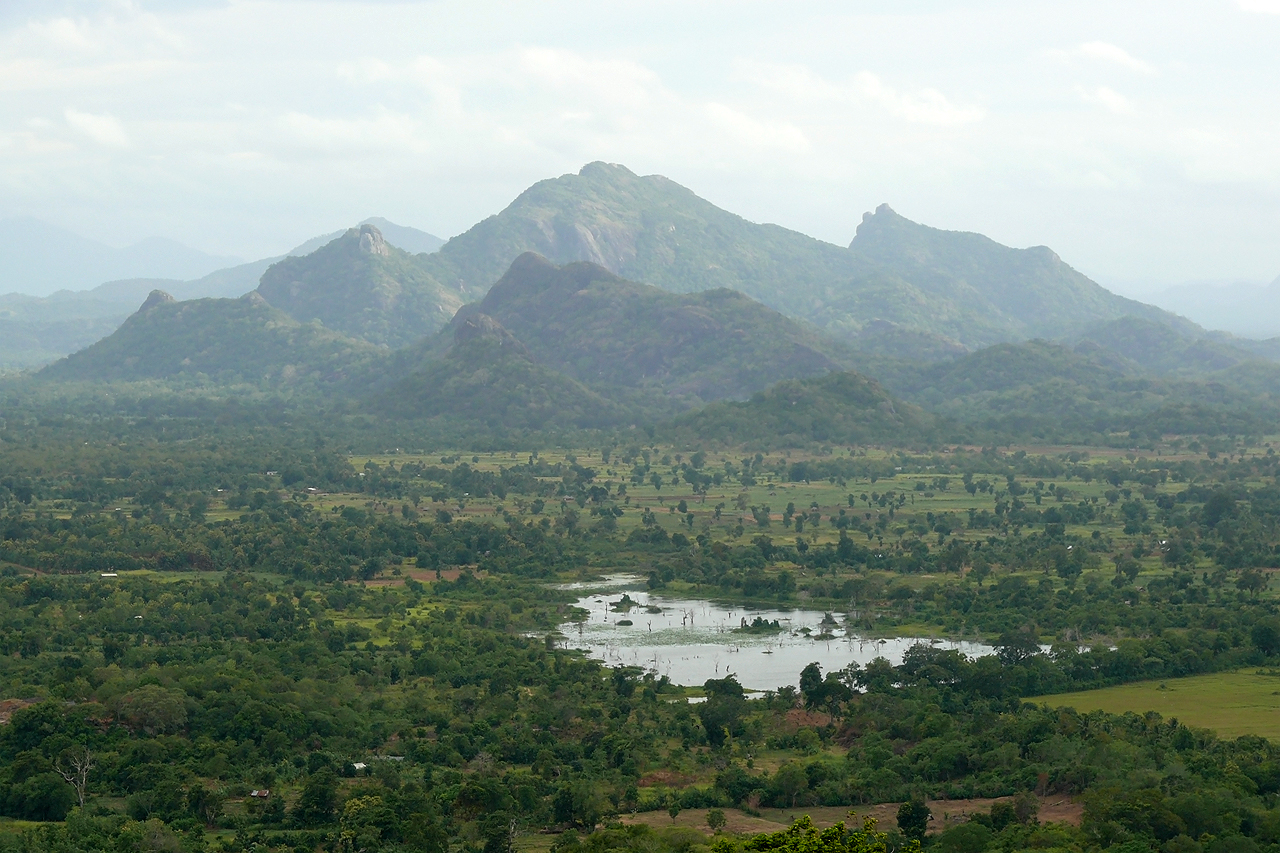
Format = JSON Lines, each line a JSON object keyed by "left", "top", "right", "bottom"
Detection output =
{"left": 1028, "top": 670, "right": 1280, "bottom": 740}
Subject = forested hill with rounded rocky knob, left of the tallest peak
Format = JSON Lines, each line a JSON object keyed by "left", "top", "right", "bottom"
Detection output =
{"left": 257, "top": 224, "right": 463, "bottom": 347}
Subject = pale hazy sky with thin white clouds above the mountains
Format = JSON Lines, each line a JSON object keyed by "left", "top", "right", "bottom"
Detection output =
{"left": 0, "top": 0, "right": 1280, "bottom": 289}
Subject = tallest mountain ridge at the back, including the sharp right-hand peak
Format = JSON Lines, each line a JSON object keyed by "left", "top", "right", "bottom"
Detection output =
{"left": 424, "top": 163, "right": 1190, "bottom": 355}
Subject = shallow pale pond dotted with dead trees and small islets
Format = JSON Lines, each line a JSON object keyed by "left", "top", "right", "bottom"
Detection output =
{"left": 559, "top": 576, "right": 995, "bottom": 690}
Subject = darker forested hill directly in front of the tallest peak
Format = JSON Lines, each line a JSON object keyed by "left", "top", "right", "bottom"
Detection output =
{"left": 440, "top": 252, "right": 852, "bottom": 406}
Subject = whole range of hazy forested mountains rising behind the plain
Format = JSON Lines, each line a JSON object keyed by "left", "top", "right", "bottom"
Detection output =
{"left": 22, "top": 164, "right": 1280, "bottom": 442}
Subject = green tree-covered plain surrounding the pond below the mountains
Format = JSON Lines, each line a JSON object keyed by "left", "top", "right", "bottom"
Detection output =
{"left": 0, "top": 384, "right": 1280, "bottom": 853}
